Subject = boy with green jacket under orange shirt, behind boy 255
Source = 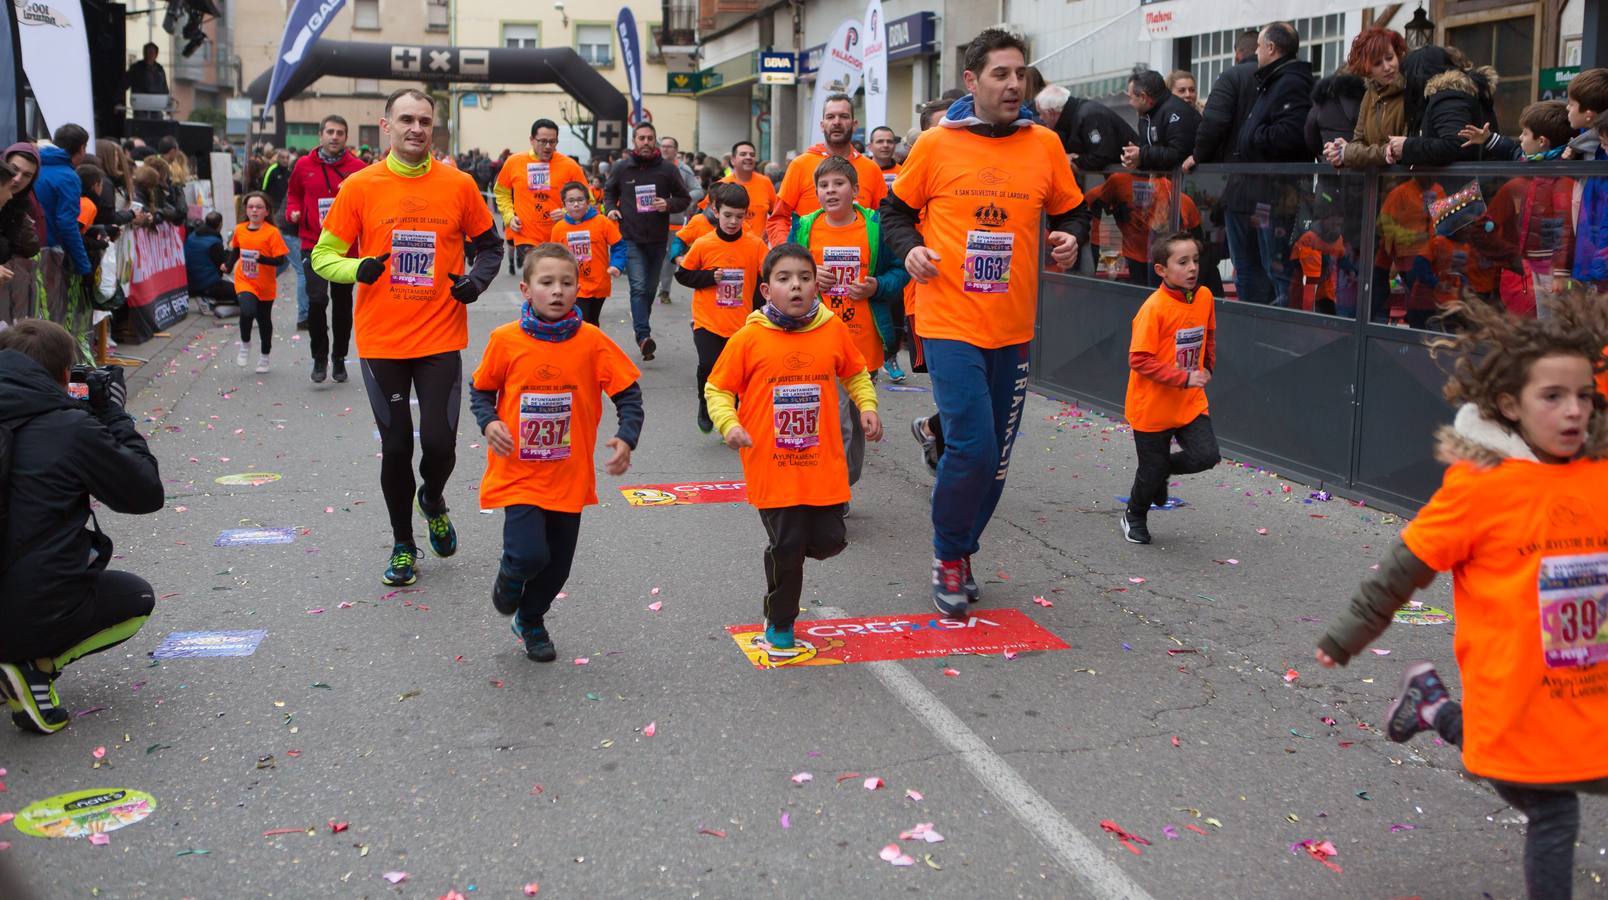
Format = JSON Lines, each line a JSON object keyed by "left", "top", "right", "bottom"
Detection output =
{"left": 788, "top": 156, "right": 910, "bottom": 484}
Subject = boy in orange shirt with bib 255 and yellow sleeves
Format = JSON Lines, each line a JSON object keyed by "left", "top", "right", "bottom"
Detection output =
{"left": 704, "top": 244, "right": 883, "bottom": 654}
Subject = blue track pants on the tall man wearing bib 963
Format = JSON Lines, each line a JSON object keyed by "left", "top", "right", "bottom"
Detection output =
{"left": 923, "top": 339, "right": 1028, "bottom": 559}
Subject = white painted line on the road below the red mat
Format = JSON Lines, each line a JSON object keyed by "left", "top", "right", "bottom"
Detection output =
{"left": 818, "top": 606, "right": 1151, "bottom": 900}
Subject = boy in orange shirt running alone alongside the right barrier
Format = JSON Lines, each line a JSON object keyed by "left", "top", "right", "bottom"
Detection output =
{"left": 1122, "top": 231, "right": 1219, "bottom": 543}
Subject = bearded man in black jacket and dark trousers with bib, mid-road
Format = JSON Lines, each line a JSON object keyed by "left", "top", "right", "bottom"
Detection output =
{"left": 603, "top": 122, "right": 693, "bottom": 360}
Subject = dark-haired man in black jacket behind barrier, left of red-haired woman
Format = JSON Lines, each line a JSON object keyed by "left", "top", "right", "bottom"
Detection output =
{"left": 1224, "top": 23, "right": 1312, "bottom": 307}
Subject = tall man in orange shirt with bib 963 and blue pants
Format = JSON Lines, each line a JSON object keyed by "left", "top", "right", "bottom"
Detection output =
{"left": 880, "top": 29, "right": 1089, "bottom": 617}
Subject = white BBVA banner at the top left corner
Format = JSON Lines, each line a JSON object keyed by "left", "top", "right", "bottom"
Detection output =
{"left": 13, "top": 0, "right": 95, "bottom": 146}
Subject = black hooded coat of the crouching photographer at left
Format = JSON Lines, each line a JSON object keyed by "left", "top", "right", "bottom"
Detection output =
{"left": 0, "top": 350, "right": 162, "bottom": 659}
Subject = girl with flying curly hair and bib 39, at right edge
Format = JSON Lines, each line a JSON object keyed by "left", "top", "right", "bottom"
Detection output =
{"left": 1317, "top": 297, "right": 1608, "bottom": 900}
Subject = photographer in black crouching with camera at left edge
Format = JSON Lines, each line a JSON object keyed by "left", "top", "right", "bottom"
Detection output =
{"left": 0, "top": 318, "right": 162, "bottom": 734}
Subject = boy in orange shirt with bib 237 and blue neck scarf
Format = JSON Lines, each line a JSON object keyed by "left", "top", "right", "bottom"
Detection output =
{"left": 470, "top": 243, "right": 642, "bottom": 662}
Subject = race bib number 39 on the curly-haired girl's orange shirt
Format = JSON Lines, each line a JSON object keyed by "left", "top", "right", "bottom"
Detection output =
{"left": 1536, "top": 553, "right": 1608, "bottom": 669}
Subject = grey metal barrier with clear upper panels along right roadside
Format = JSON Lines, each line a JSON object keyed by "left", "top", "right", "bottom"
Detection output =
{"left": 1032, "top": 162, "right": 1608, "bottom": 514}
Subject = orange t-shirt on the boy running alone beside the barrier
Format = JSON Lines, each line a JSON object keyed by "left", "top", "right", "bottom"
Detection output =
{"left": 1122, "top": 288, "right": 1217, "bottom": 431}
